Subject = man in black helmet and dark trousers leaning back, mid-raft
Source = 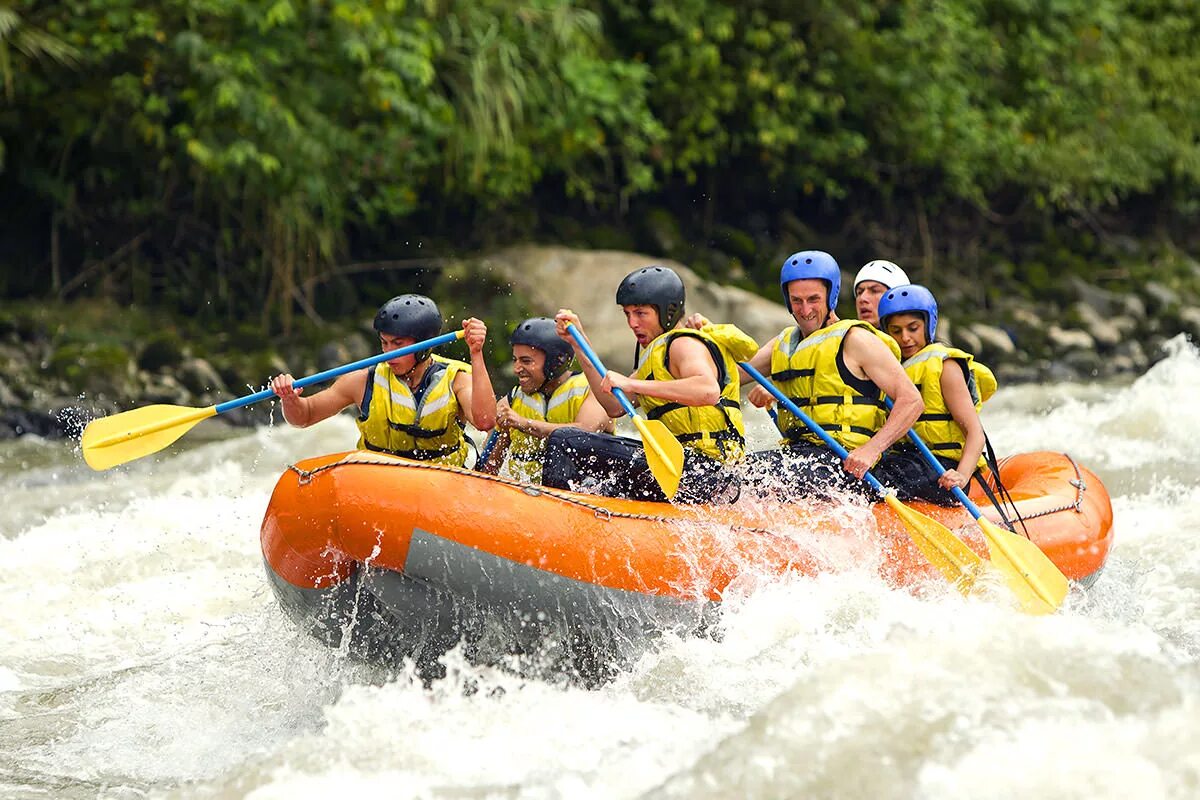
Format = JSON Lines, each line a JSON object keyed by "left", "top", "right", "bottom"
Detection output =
{"left": 542, "top": 265, "right": 757, "bottom": 503}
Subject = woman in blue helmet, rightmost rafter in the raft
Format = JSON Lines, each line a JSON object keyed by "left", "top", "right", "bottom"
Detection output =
{"left": 878, "top": 284, "right": 996, "bottom": 505}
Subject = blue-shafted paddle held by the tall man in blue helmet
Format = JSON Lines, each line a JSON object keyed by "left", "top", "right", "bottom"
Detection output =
{"left": 742, "top": 362, "right": 983, "bottom": 595}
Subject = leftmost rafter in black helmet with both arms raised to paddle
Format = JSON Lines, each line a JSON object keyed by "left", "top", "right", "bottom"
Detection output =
{"left": 271, "top": 294, "right": 496, "bottom": 467}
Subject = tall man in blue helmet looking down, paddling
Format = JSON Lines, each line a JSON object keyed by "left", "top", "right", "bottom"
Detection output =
{"left": 749, "top": 251, "right": 924, "bottom": 495}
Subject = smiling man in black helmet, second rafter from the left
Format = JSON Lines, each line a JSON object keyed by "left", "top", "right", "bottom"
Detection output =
{"left": 482, "top": 317, "right": 613, "bottom": 483}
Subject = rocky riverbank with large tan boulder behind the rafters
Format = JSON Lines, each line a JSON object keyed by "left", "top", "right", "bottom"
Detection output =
{"left": 0, "top": 246, "right": 1200, "bottom": 439}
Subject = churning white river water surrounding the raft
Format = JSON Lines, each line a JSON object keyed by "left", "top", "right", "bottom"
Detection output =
{"left": 0, "top": 339, "right": 1200, "bottom": 800}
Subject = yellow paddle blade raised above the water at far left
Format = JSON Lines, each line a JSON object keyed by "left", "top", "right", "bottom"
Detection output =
{"left": 82, "top": 405, "right": 217, "bottom": 471}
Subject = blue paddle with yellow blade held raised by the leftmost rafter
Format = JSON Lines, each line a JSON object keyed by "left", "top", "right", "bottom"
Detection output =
{"left": 82, "top": 331, "right": 463, "bottom": 471}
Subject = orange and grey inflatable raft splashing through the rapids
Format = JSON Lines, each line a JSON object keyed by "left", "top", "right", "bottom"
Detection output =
{"left": 262, "top": 451, "right": 1112, "bottom": 669}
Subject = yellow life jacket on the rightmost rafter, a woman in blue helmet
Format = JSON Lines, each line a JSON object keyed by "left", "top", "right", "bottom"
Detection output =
{"left": 904, "top": 342, "right": 996, "bottom": 467}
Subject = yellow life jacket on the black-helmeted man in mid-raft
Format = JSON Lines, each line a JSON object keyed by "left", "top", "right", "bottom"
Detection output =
{"left": 634, "top": 325, "right": 756, "bottom": 463}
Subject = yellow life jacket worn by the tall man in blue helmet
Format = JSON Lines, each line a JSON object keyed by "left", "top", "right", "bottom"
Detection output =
{"left": 770, "top": 319, "right": 900, "bottom": 450}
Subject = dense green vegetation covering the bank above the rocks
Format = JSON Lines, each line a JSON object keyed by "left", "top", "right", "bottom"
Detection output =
{"left": 0, "top": 0, "right": 1200, "bottom": 330}
